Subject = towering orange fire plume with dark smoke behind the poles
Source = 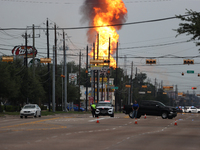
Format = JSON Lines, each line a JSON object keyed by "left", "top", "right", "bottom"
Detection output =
{"left": 79, "top": 0, "right": 127, "bottom": 68}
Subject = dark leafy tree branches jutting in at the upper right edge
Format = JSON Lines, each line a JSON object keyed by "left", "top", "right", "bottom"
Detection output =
{"left": 175, "top": 9, "right": 200, "bottom": 50}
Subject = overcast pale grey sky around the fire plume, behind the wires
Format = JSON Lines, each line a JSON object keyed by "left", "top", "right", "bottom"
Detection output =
{"left": 0, "top": 0, "right": 200, "bottom": 94}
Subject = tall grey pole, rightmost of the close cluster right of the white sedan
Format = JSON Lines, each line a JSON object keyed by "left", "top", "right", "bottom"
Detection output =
{"left": 63, "top": 30, "right": 67, "bottom": 111}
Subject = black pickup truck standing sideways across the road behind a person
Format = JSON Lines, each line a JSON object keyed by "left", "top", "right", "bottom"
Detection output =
{"left": 123, "top": 100, "right": 177, "bottom": 119}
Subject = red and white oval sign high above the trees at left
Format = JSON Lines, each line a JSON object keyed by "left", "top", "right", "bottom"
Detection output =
{"left": 12, "top": 45, "right": 37, "bottom": 58}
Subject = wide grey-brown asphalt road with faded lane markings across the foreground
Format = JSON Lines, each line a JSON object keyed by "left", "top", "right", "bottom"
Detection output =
{"left": 0, "top": 114, "right": 200, "bottom": 150}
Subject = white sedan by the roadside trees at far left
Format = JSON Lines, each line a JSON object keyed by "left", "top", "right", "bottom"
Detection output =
{"left": 20, "top": 104, "right": 41, "bottom": 118}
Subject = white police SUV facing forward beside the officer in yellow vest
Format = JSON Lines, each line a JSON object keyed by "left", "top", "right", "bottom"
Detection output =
{"left": 95, "top": 101, "right": 114, "bottom": 117}
